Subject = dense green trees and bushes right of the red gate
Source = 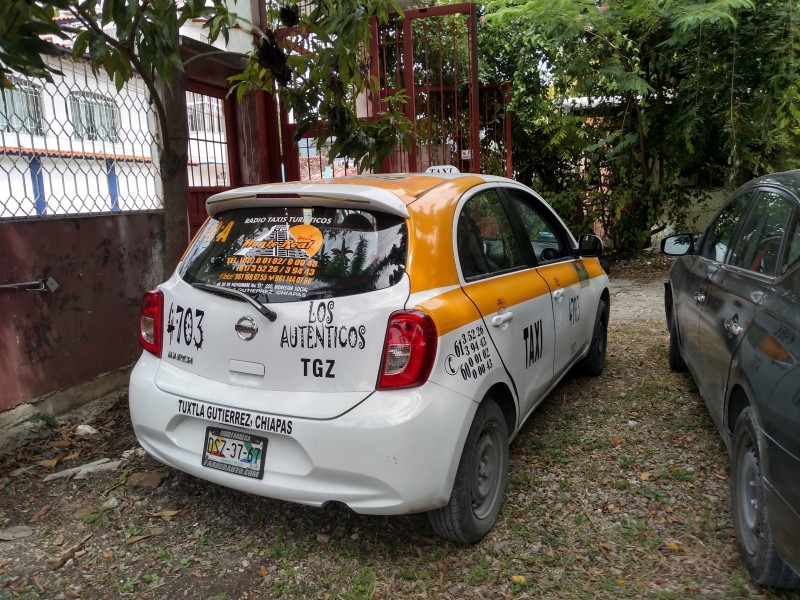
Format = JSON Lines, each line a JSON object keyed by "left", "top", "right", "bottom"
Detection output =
{"left": 479, "top": 0, "right": 800, "bottom": 253}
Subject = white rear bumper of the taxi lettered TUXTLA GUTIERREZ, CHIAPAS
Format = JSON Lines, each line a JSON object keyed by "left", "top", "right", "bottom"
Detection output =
{"left": 129, "top": 355, "right": 478, "bottom": 515}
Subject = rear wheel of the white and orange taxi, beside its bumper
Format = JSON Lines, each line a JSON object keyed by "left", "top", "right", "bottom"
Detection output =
{"left": 428, "top": 398, "right": 508, "bottom": 544}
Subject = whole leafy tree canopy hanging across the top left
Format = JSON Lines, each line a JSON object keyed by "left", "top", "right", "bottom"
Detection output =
{"left": 0, "top": 0, "right": 412, "bottom": 169}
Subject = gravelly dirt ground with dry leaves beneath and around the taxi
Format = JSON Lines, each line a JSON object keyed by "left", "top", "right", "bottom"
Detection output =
{"left": 0, "top": 257, "right": 797, "bottom": 600}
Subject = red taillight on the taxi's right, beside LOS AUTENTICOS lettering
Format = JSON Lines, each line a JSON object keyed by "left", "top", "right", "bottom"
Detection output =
{"left": 378, "top": 310, "right": 439, "bottom": 390}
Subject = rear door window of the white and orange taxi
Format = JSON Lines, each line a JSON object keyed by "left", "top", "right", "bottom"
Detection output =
{"left": 456, "top": 190, "right": 523, "bottom": 279}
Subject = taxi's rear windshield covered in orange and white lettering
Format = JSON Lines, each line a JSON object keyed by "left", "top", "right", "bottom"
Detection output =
{"left": 180, "top": 207, "right": 407, "bottom": 302}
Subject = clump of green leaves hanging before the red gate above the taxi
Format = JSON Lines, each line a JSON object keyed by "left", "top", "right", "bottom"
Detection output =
{"left": 231, "top": 0, "right": 412, "bottom": 171}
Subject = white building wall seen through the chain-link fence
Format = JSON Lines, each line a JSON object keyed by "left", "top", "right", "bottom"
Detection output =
{"left": 0, "top": 57, "right": 163, "bottom": 218}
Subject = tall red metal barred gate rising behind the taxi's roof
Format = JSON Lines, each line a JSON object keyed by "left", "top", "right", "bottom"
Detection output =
{"left": 282, "top": 3, "right": 511, "bottom": 181}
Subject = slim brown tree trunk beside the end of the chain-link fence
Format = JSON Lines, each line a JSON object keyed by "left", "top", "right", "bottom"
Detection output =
{"left": 156, "top": 68, "right": 189, "bottom": 279}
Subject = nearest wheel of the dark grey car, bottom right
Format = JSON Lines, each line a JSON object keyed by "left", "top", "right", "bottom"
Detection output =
{"left": 731, "top": 406, "right": 800, "bottom": 589}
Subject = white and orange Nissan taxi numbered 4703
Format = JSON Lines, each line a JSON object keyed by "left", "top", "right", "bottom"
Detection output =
{"left": 130, "top": 173, "right": 609, "bottom": 543}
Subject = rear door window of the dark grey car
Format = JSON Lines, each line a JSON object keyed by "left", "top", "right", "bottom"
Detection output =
{"left": 730, "top": 191, "right": 794, "bottom": 275}
